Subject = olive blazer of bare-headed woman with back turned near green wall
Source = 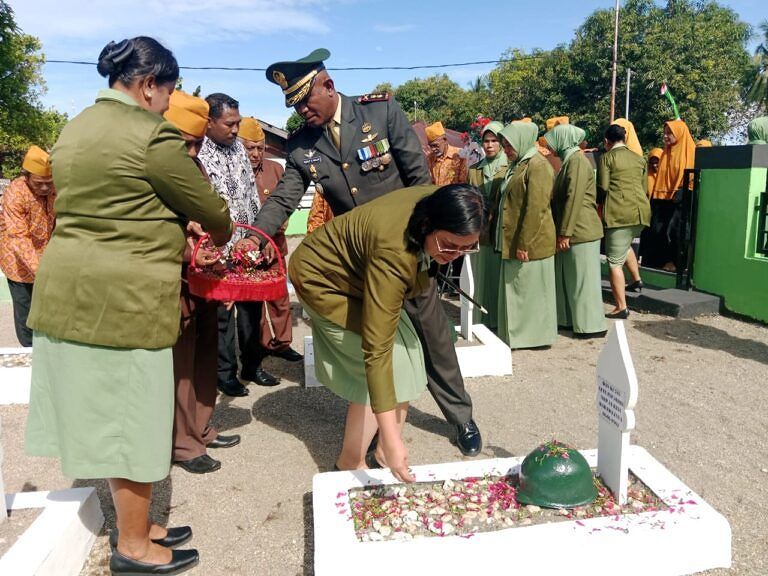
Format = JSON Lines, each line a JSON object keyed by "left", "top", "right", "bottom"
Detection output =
{"left": 597, "top": 146, "right": 651, "bottom": 228}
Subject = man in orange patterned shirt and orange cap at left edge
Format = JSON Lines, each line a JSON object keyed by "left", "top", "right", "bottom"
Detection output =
{"left": 0, "top": 146, "right": 56, "bottom": 347}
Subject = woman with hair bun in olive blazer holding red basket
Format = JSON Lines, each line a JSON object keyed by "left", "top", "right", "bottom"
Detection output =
{"left": 26, "top": 36, "right": 232, "bottom": 576}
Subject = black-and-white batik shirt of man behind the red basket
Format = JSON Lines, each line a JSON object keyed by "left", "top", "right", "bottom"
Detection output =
{"left": 197, "top": 137, "right": 261, "bottom": 242}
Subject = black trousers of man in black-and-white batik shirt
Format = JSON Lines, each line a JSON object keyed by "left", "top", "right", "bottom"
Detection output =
{"left": 218, "top": 302, "right": 266, "bottom": 386}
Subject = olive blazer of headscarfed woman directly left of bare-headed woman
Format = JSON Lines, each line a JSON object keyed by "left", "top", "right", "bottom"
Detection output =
{"left": 552, "top": 151, "right": 603, "bottom": 244}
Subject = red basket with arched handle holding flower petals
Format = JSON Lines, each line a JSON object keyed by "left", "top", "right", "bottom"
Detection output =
{"left": 187, "top": 223, "right": 288, "bottom": 302}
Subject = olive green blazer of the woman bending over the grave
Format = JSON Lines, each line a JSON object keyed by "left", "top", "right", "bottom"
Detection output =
{"left": 288, "top": 185, "right": 438, "bottom": 413}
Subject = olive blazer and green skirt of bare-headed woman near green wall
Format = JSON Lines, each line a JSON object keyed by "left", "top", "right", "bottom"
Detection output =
{"left": 597, "top": 144, "right": 651, "bottom": 268}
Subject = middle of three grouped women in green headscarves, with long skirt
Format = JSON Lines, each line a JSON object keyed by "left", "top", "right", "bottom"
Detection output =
{"left": 496, "top": 122, "right": 557, "bottom": 348}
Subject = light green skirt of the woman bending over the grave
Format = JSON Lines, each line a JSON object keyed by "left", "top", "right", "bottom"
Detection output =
{"left": 302, "top": 303, "right": 427, "bottom": 404}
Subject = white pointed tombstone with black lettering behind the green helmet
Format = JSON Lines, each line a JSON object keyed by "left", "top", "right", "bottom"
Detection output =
{"left": 597, "top": 321, "right": 637, "bottom": 504}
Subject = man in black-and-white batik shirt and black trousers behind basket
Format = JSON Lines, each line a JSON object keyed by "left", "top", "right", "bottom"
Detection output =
{"left": 198, "top": 93, "right": 280, "bottom": 396}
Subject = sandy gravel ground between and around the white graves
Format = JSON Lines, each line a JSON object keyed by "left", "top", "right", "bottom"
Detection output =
{"left": 0, "top": 264, "right": 768, "bottom": 576}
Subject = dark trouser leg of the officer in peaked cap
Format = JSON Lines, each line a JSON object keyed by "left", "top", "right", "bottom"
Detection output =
{"left": 403, "top": 278, "right": 472, "bottom": 425}
